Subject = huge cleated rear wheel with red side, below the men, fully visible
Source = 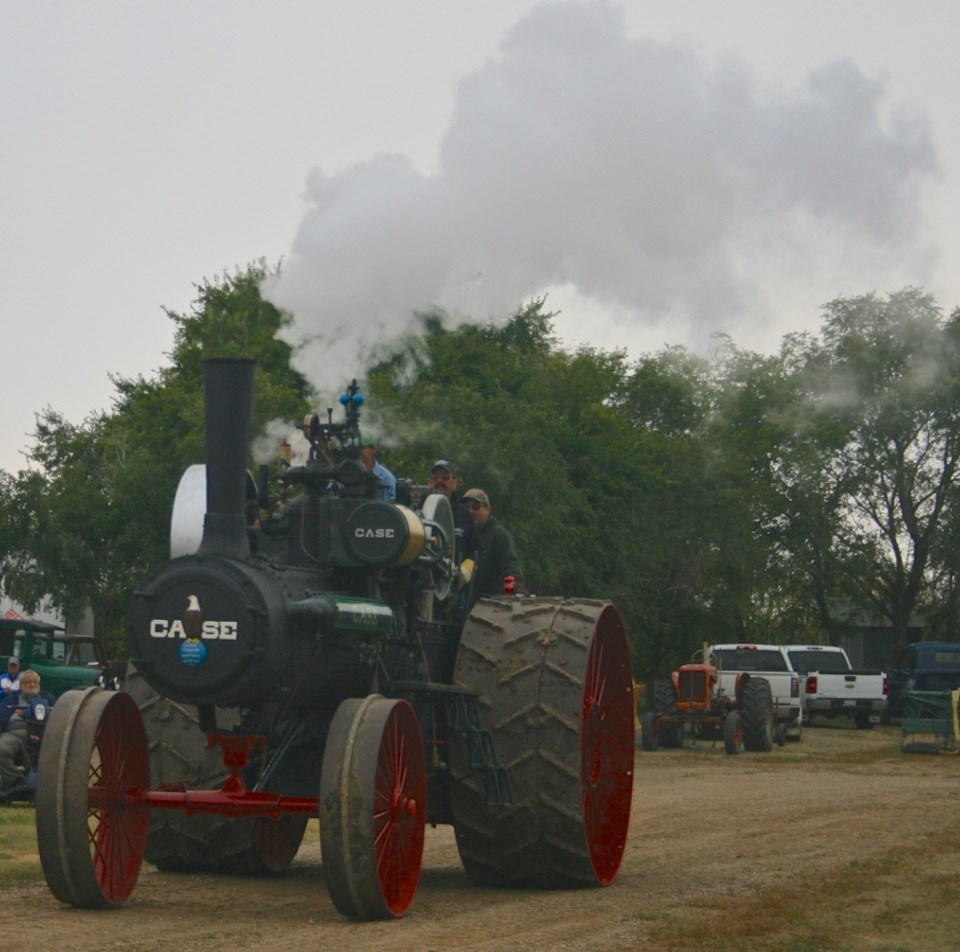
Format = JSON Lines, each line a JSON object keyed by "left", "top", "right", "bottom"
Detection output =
{"left": 449, "top": 598, "right": 634, "bottom": 888}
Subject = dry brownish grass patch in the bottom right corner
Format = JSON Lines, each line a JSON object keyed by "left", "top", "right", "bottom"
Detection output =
{"left": 636, "top": 832, "right": 960, "bottom": 952}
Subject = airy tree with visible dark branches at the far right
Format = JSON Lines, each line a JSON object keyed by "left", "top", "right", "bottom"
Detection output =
{"left": 777, "top": 288, "right": 960, "bottom": 644}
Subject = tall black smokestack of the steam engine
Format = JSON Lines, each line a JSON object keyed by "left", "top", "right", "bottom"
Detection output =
{"left": 199, "top": 357, "right": 256, "bottom": 557}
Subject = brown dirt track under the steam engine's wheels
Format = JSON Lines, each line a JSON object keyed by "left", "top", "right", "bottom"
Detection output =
{"left": 2, "top": 726, "right": 960, "bottom": 952}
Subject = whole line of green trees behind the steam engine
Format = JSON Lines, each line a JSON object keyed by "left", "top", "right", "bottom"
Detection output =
{"left": 0, "top": 263, "right": 960, "bottom": 677}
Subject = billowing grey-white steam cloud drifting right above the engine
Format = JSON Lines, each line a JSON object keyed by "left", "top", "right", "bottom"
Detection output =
{"left": 265, "top": 2, "right": 936, "bottom": 390}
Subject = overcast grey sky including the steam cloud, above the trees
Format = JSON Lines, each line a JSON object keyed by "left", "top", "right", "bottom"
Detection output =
{"left": 0, "top": 0, "right": 960, "bottom": 471}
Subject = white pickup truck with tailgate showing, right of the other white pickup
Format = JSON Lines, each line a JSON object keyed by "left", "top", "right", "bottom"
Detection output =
{"left": 787, "top": 645, "right": 888, "bottom": 730}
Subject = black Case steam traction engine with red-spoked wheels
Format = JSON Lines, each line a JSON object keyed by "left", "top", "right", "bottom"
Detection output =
{"left": 36, "top": 360, "right": 633, "bottom": 918}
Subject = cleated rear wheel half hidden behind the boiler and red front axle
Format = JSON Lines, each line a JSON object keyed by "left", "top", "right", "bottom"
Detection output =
{"left": 123, "top": 663, "right": 307, "bottom": 874}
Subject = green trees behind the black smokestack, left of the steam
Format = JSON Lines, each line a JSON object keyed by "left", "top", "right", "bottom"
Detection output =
{"left": 0, "top": 263, "right": 308, "bottom": 650}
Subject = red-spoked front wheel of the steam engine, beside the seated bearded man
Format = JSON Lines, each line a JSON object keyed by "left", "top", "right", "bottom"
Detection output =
{"left": 36, "top": 688, "right": 150, "bottom": 909}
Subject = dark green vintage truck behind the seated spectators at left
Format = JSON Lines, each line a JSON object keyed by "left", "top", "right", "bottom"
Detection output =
{"left": 0, "top": 618, "right": 122, "bottom": 697}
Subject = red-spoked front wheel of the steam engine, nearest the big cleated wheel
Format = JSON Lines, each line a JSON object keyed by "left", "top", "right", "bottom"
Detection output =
{"left": 320, "top": 694, "right": 427, "bottom": 919}
